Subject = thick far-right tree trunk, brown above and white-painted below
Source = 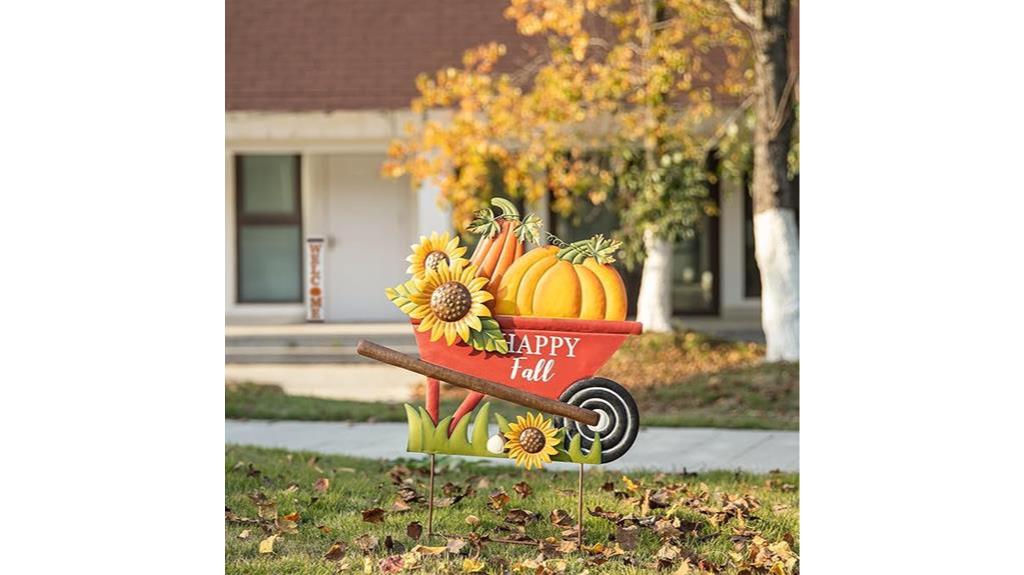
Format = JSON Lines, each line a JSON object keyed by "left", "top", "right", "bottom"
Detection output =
{"left": 751, "top": 0, "right": 800, "bottom": 361}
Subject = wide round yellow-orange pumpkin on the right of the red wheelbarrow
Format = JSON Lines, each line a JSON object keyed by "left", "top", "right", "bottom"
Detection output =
{"left": 495, "top": 235, "right": 628, "bottom": 320}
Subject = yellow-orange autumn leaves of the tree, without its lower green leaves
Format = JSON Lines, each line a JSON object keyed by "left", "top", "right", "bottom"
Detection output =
{"left": 381, "top": 0, "right": 751, "bottom": 231}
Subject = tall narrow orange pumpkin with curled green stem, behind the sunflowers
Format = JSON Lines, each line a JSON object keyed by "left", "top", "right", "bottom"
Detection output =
{"left": 469, "top": 197, "right": 541, "bottom": 296}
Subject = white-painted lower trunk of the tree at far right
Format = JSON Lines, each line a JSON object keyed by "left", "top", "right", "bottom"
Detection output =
{"left": 753, "top": 208, "right": 800, "bottom": 361}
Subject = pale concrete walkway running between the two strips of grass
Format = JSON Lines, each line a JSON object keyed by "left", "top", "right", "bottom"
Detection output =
{"left": 224, "top": 419, "right": 800, "bottom": 473}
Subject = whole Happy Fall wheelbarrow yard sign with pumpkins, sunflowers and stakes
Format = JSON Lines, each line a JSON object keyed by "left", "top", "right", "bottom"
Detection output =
{"left": 356, "top": 198, "right": 642, "bottom": 542}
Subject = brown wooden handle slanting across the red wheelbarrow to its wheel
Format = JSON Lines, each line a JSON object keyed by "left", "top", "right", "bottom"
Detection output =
{"left": 355, "top": 340, "right": 601, "bottom": 426}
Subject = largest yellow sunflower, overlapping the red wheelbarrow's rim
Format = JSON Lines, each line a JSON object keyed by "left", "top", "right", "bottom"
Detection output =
{"left": 408, "top": 259, "right": 494, "bottom": 346}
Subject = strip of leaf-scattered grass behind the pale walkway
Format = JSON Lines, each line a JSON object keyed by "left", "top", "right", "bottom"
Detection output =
{"left": 224, "top": 331, "right": 800, "bottom": 430}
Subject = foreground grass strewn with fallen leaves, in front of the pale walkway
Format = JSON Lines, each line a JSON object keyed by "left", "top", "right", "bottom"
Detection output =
{"left": 224, "top": 446, "right": 800, "bottom": 574}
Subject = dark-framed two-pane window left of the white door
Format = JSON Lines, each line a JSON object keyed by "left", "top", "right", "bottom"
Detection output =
{"left": 234, "top": 154, "right": 302, "bottom": 303}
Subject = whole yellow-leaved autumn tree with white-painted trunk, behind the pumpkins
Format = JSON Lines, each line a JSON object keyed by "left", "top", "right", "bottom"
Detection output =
{"left": 383, "top": 0, "right": 782, "bottom": 331}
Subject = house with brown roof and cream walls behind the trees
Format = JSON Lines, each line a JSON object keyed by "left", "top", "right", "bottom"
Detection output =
{"left": 224, "top": 0, "right": 782, "bottom": 323}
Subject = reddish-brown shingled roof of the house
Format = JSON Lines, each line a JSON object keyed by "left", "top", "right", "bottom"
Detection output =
{"left": 225, "top": 0, "right": 800, "bottom": 112}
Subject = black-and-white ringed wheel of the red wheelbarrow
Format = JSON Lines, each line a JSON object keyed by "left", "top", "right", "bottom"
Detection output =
{"left": 554, "top": 378, "right": 640, "bottom": 463}
